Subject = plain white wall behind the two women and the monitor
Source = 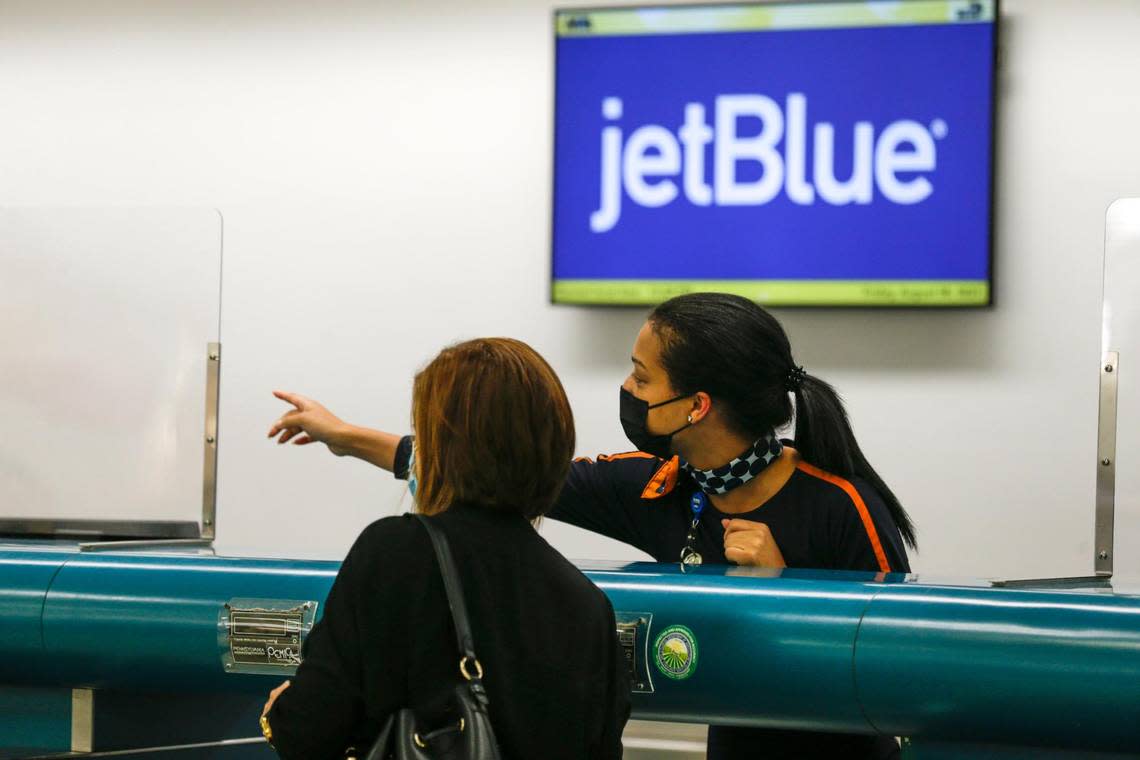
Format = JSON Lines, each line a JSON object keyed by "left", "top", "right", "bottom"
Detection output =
{"left": 0, "top": 0, "right": 1140, "bottom": 575}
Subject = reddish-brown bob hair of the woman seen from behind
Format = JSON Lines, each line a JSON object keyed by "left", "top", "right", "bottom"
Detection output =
{"left": 412, "top": 337, "right": 575, "bottom": 520}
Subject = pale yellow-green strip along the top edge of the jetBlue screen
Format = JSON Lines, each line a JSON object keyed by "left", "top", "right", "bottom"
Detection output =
{"left": 555, "top": 0, "right": 994, "bottom": 36}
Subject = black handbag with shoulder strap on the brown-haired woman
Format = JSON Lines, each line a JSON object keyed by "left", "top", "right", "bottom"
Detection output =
{"left": 355, "top": 515, "right": 502, "bottom": 760}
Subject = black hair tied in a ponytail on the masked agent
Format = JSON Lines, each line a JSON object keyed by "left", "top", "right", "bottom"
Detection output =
{"left": 649, "top": 293, "right": 917, "bottom": 548}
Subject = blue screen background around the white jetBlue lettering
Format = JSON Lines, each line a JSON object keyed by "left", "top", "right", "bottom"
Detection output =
{"left": 553, "top": 23, "right": 993, "bottom": 280}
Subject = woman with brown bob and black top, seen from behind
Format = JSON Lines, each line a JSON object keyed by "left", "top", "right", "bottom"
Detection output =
{"left": 263, "top": 338, "right": 629, "bottom": 760}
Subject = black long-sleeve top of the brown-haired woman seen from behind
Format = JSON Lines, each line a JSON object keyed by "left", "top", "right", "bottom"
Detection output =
{"left": 269, "top": 505, "right": 629, "bottom": 760}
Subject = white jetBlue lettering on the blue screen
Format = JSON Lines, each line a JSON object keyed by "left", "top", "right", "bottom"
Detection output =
{"left": 589, "top": 92, "right": 950, "bottom": 232}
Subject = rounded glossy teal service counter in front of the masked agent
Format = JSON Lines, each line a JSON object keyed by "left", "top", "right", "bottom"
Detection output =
{"left": 0, "top": 546, "right": 1140, "bottom": 757}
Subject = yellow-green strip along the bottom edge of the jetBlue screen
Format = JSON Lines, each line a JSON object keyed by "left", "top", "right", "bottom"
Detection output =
{"left": 554, "top": 279, "right": 990, "bottom": 307}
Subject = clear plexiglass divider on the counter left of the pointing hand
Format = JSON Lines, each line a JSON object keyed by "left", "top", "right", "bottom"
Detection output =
{"left": 0, "top": 207, "right": 222, "bottom": 537}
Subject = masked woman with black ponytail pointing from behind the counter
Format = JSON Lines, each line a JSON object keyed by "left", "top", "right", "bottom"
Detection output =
{"left": 270, "top": 293, "right": 915, "bottom": 760}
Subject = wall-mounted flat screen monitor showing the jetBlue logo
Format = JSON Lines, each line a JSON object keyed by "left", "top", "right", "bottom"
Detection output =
{"left": 551, "top": 0, "right": 998, "bottom": 307}
